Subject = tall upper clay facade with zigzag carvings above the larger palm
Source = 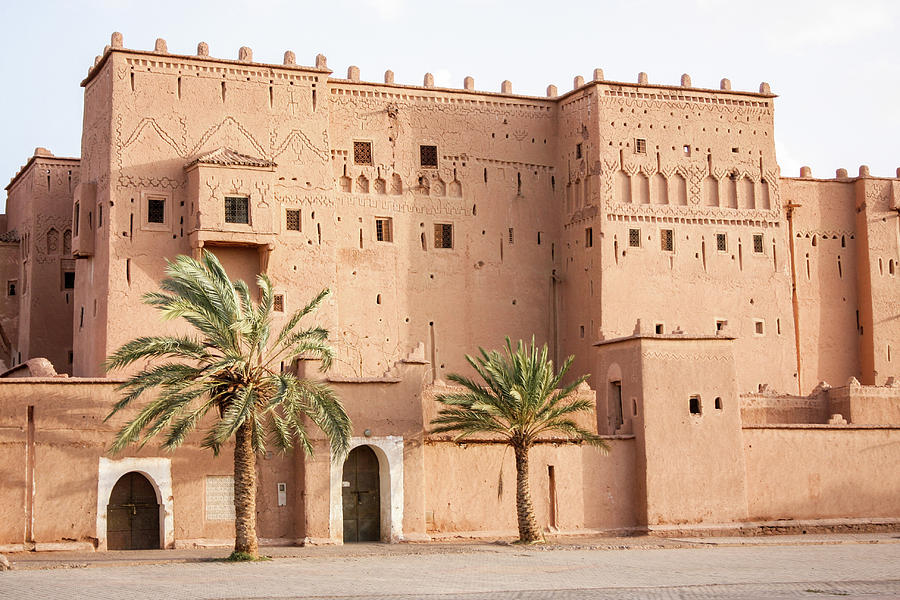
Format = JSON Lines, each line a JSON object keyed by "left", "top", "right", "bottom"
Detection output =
{"left": 79, "top": 52, "right": 555, "bottom": 384}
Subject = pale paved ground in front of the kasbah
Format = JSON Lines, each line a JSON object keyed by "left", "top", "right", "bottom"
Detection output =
{"left": 0, "top": 534, "right": 900, "bottom": 600}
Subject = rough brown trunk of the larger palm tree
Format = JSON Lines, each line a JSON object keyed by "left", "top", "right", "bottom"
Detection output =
{"left": 234, "top": 420, "right": 259, "bottom": 558}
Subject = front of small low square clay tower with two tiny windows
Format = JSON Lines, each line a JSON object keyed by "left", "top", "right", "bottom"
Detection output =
{"left": 616, "top": 334, "right": 747, "bottom": 528}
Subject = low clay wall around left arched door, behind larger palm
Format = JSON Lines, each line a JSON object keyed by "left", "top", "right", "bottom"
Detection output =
{"left": 0, "top": 379, "right": 302, "bottom": 545}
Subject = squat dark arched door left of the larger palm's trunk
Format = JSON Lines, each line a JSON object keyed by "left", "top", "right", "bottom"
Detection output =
{"left": 106, "top": 471, "right": 160, "bottom": 550}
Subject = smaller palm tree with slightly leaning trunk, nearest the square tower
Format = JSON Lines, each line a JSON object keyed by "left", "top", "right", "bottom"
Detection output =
{"left": 431, "top": 338, "right": 609, "bottom": 543}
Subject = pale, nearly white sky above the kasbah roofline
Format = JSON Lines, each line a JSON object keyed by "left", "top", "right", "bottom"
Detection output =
{"left": 0, "top": 0, "right": 900, "bottom": 205}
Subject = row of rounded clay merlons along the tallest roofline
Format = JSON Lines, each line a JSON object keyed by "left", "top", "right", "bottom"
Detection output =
{"left": 81, "top": 33, "right": 778, "bottom": 103}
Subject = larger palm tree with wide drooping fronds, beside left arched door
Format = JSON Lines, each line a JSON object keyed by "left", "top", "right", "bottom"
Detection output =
{"left": 105, "top": 252, "right": 350, "bottom": 558}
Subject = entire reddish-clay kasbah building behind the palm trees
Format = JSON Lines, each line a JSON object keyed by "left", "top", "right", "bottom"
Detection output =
{"left": 0, "top": 34, "right": 900, "bottom": 551}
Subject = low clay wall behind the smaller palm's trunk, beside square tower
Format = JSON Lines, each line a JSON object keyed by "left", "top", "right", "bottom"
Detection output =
{"left": 425, "top": 438, "right": 635, "bottom": 538}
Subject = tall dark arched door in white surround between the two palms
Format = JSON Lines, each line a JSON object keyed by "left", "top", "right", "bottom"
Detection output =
{"left": 341, "top": 446, "right": 381, "bottom": 543}
